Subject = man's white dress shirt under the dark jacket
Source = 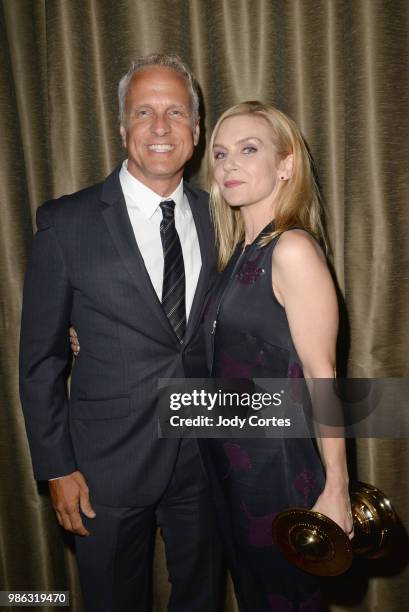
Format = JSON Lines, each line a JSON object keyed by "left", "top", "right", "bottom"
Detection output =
{"left": 119, "top": 160, "right": 202, "bottom": 321}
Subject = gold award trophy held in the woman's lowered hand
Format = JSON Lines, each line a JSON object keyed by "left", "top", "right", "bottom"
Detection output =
{"left": 273, "top": 482, "right": 397, "bottom": 576}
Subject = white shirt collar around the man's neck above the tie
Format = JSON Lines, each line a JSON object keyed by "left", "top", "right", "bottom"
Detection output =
{"left": 119, "top": 159, "right": 187, "bottom": 219}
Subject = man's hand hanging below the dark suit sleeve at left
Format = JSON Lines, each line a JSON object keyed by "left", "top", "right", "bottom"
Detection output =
{"left": 49, "top": 471, "right": 96, "bottom": 536}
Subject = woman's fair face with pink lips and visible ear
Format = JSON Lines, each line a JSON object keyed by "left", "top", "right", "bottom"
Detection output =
{"left": 213, "top": 115, "right": 292, "bottom": 206}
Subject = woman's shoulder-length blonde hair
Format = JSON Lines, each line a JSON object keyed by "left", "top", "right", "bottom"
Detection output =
{"left": 207, "top": 101, "right": 325, "bottom": 270}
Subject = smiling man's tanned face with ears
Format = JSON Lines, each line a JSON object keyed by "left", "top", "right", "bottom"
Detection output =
{"left": 120, "top": 66, "right": 199, "bottom": 196}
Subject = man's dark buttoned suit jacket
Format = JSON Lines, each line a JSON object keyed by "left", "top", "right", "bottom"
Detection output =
{"left": 20, "top": 169, "right": 214, "bottom": 506}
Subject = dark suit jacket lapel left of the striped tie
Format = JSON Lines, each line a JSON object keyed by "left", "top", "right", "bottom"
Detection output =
{"left": 101, "top": 168, "right": 176, "bottom": 340}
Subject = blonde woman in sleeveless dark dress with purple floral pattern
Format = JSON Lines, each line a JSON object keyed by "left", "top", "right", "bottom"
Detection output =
{"left": 200, "top": 102, "right": 352, "bottom": 612}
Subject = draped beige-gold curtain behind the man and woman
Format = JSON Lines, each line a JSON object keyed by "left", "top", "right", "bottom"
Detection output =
{"left": 0, "top": 0, "right": 409, "bottom": 612}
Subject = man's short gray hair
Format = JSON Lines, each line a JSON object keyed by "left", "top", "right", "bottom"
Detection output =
{"left": 118, "top": 53, "right": 199, "bottom": 129}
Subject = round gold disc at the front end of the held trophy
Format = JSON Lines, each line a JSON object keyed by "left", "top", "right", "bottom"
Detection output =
{"left": 273, "top": 508, "right": 353, "bottom": 576}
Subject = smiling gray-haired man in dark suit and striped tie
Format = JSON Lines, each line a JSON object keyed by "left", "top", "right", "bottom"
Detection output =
{"left": 20, "top": 55, "right": 220, "bottom": 612}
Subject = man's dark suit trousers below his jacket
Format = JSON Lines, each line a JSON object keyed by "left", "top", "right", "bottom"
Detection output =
{"left": 75, "top": 439, "right": 224, "bottom": 612}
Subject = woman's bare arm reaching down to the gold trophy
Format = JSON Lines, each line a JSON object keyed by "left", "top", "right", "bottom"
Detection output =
{"left": 272, "top": 230, "right": 353, "bottom": 537}
